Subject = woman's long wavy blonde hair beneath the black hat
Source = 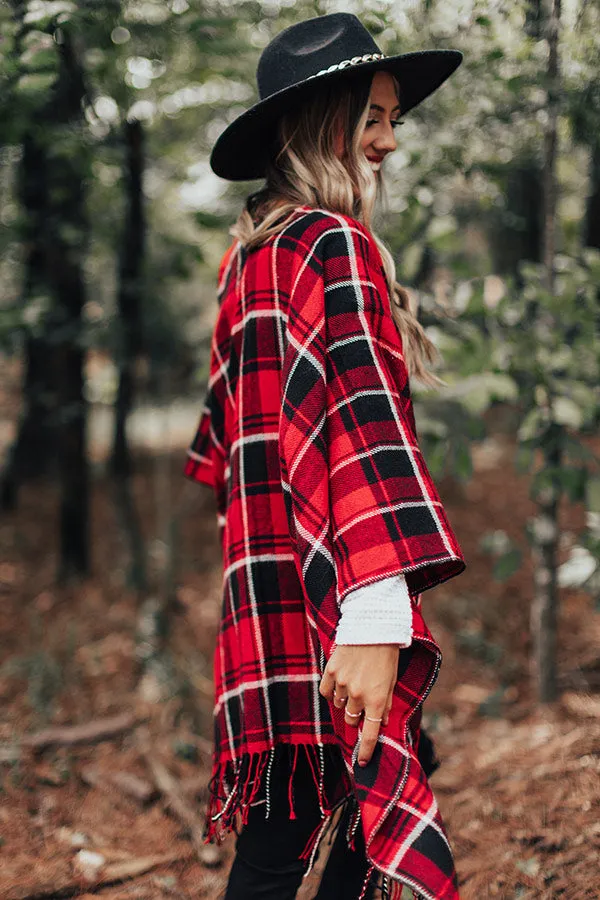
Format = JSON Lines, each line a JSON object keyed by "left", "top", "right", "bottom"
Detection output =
{"left": 229, "top": 73, "right": 445, "bottom": 387}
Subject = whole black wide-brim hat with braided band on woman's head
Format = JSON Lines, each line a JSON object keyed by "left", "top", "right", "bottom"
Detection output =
{"left": 210, "top": 13, "right": 463, "bottom": 181}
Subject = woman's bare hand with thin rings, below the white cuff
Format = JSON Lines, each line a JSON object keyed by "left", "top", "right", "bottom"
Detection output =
{"left": 319, "top": 644, "right": 400, "bottom": 766}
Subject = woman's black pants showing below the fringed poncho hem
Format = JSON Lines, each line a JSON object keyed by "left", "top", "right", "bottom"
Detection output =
{"left": 225, "top": 746, "right": 374, "bottom": 900}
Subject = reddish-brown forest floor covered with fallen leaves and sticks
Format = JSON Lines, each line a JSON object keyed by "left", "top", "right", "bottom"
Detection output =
{"left": 0, "top": 410, "right": 600, "bottom": 900}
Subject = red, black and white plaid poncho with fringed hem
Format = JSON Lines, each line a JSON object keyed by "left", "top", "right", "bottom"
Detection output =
{"left": 185, "top": 206, "right": 465, "bottom": 900}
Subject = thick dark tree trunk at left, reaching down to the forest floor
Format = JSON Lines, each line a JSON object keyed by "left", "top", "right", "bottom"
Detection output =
{"left": 45, "top": 28, "right": 90, "bottom": 580}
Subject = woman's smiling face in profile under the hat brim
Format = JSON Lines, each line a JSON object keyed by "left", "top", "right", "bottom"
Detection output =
{"left": 336, "top": 72, "right": 400, "bottom": 172}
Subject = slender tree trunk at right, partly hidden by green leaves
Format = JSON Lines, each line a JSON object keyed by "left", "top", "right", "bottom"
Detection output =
{"left": 531, "top": 0, "right": 562, "bottom": 703}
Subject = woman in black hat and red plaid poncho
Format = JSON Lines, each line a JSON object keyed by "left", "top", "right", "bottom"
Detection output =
{"left": 186, "top": 13, "right": 465, "bottom": 900}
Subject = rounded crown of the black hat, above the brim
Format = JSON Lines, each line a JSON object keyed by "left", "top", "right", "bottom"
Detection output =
{"left": 256, "top": 13, "right": 382, "bottom": 100}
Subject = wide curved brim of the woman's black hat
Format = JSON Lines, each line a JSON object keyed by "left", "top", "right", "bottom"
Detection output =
{"left": 210, "top": 50, "right": 463, "bottom": 181}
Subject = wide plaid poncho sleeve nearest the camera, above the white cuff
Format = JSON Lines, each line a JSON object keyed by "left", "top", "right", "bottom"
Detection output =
{"left": 280, "top": 216, "right": 465, "bottom": 639}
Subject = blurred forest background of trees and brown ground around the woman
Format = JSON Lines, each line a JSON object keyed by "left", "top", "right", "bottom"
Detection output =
{"left": 0, "top": 0, "right": 600, "bottom": 900}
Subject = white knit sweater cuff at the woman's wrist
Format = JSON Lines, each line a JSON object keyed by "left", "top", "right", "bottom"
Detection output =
{"left": 335, "top": 575, "right": 412, "bottom": 647}
